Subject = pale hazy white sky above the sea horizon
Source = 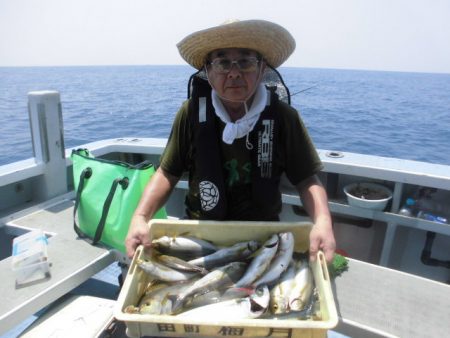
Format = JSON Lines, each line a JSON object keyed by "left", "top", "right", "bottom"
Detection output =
{"left": 0, "top": 0, "right": 450, "bottom": 73}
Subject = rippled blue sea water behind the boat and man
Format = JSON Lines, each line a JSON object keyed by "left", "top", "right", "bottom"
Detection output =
{"left": 0, "top": 66, "right": 450, "bottom": 165}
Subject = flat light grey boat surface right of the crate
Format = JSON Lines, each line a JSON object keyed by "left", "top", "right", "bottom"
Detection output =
{"left": 332, "top": 259, "right": 450, "bottom": 337}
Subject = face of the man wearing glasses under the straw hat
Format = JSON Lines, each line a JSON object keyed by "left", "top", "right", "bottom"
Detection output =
{"left": 206, "top": 48, "right": 265, "bottom": 102}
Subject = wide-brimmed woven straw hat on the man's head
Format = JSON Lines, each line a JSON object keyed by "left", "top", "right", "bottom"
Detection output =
{"left": 177, "top": 20, "right": 295, "bottom": 69}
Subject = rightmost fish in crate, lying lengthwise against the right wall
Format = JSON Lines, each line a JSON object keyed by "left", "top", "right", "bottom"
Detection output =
{"left": 289, "top": 259, "right": 314, "bottom": 311}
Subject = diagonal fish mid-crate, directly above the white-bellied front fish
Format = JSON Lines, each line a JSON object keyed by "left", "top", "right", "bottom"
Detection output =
{"left": 173, "top": 262, "right": 247, "bottom": 312}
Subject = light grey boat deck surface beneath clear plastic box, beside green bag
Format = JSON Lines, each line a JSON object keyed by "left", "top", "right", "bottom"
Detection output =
{"left": 0, "top": 197, "right": 115, "bottom": 334}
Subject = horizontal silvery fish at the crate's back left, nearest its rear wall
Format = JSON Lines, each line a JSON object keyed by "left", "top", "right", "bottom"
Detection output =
{"left": 151, "top": 236, "right": 218, "bottom": 259}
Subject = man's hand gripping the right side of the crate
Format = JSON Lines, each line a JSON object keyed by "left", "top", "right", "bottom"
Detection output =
{"left": 309, "top": 221, "right": 336, "bottom": 263}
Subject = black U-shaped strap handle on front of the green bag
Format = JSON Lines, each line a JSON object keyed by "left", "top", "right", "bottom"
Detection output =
{"left": 73, "top": 167, "right": 129, "bottom": 245}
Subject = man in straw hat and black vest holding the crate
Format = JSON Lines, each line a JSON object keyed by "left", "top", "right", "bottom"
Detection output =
{"left": 126, "top": 20, "right": 335, "bottom": 261}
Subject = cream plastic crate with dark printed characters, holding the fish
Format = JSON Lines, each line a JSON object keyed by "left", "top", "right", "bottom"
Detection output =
{"left": 114, "top": 220, "right": 338, "bottom": 338}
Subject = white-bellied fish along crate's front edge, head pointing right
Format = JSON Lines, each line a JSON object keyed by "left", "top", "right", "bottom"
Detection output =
{"left": 177, "top": 285, "right": 270, "bottom": 320}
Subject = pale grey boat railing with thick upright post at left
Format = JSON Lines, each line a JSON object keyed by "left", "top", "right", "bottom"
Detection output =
{"left": 0, "top": 91, "right": 450, "bottom": 270}
